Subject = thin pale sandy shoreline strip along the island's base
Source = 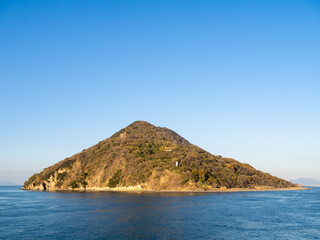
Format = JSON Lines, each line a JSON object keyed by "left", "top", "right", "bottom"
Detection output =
{"left": 21, "top": 187, "right": 312, "bottom": 193}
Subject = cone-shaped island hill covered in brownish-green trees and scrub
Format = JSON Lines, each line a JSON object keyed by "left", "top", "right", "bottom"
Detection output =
{"left": 23, "top": 121, "right": 295, "bottom": 191}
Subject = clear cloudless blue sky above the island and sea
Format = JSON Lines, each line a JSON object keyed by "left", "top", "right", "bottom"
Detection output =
{"left": 0, "top": 0, "right": 320, "bottom": 183}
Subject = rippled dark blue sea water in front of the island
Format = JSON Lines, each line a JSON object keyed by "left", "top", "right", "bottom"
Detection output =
{"left": 0, "top": 187, "right": 320, "bottom": 240}
